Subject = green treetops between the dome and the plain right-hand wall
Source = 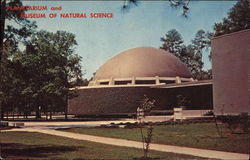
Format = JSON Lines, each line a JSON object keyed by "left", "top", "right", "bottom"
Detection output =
{"left": 160, "top": 29, "right": 212, "bottom": 80}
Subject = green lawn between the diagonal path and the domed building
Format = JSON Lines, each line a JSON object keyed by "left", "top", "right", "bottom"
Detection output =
{"left": 61, "top": 123, "right": 249, "bottom": 153}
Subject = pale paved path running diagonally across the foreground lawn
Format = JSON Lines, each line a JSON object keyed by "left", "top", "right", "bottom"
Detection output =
{"left": 3, "top": 128, "right": 249, "bottom": 160}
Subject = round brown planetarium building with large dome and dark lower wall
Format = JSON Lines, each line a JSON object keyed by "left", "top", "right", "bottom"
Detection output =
{"left": 68, "top": 47, "right": 213, "bottom": 115}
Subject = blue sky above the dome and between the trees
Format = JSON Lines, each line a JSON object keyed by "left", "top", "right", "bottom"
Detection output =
{"left": 17, "top": 1, "right": 236, "bottom": 78}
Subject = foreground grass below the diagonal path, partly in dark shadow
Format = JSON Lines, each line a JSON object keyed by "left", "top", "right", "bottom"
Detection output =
{"left": 0, "top": 132, "right": 207, "bottom": 160}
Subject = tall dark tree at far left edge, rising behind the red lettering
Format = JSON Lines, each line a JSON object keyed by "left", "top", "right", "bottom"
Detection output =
{"left": 0, "top": 0, "right": 36, "bottom": 119}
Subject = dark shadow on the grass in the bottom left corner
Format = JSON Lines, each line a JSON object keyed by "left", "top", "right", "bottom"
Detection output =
{"left": 1, "top": 143, "right": 83, "bottom": 158}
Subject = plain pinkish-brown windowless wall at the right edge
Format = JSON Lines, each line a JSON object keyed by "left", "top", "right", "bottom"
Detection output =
{"left": 212, "top": 30, "right": 250, "bottom": 115}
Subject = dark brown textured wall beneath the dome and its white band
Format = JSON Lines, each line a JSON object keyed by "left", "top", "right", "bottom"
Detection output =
{"left": 68, "top": 84, "right": 213, "bottom": 115}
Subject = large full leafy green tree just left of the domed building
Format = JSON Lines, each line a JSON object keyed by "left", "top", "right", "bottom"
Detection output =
{"left": 14, "top": 31, "right": 82, "bottom": 118}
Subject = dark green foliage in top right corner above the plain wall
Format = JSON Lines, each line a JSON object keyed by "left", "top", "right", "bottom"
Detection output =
{"left": 214, "top": 0, "right": 250, "bottom": 36}
